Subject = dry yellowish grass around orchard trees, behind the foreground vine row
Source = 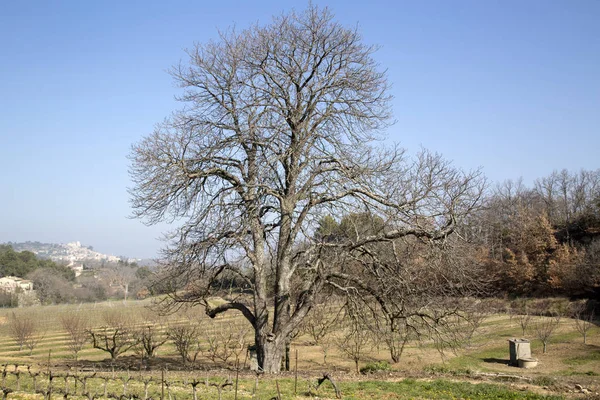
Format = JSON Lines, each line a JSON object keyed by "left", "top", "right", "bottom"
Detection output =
{"left": 0, "top": 301, "right": 600, "bottom": 391}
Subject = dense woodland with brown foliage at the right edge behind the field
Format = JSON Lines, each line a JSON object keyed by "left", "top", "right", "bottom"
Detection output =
{"left": 465, "top": 170, "right": 600, "bottom": 297}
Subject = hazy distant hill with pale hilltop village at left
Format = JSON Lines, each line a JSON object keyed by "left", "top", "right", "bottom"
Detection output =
{"left": 5, "top": 242, "right": 140, "bottom": 263}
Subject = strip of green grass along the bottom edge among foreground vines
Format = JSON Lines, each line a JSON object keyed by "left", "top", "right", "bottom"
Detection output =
{"left": 0, "top": 374, "right": 563, "bottom": 400}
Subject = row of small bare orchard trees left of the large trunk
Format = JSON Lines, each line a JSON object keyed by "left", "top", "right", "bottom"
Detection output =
{"left": 8, "top": 309, "right": 249, "bottom": 364}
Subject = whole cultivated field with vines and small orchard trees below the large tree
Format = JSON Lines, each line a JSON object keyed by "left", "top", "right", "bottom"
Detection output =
{"left": 0, "top": 301, "right": 600, "bottom": 400}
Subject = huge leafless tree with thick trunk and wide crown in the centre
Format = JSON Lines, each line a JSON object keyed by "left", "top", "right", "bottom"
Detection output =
{"left": 130, "top": 6, "right": 482, "bottom": 372}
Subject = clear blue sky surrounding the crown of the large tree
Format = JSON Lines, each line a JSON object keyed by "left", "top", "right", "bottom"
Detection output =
{"left": 0, "top": 0, "right": 600, "bottom": 257}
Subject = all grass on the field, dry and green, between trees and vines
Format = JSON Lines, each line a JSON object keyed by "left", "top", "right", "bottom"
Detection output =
{"left": 0, "top": 301, "right": 600, "bottom": 400}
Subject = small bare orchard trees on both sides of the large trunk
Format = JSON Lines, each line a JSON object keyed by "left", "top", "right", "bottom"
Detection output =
{"left": 8, "top": 296, "right": 594, "bottom": 372}
